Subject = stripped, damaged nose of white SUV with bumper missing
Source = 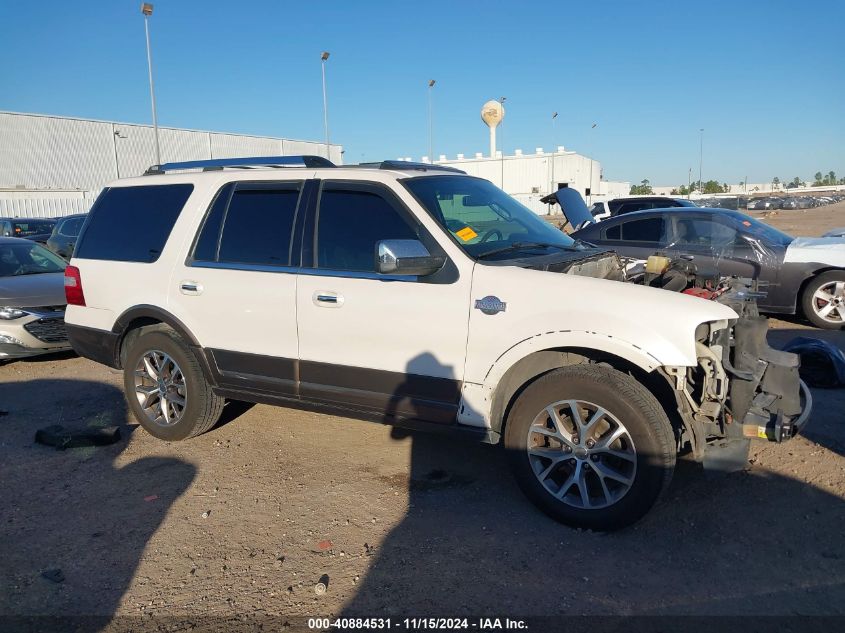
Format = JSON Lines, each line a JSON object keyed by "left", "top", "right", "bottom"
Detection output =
{"left": 664, "top": 279, "right": 812, "bottom": 467}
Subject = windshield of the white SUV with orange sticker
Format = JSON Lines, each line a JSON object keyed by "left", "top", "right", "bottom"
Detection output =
{"left": 403, "top": 176, "right": 578, "bottom": 259}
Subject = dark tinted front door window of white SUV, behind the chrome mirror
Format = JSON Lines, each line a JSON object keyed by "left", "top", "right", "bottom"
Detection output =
{"left": 317, "top": 185, "right": 418, "bottom": 272}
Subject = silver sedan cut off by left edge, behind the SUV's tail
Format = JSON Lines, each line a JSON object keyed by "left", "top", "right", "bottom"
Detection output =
{"left": 0, "top": 237, "right": 70, "bottom": 362}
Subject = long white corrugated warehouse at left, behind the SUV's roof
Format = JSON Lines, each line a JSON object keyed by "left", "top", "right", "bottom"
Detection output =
{"left": 0, "top": 111, "right": 343, "bottom": 217}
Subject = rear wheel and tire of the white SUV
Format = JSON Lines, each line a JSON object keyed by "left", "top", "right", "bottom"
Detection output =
{"left": 123, "top": 329, "right": 225, "bottom": 442}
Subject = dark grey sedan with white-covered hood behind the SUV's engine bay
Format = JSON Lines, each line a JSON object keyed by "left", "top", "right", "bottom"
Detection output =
{"left": 550, "top": 192, "right": 845, "bottom": 330}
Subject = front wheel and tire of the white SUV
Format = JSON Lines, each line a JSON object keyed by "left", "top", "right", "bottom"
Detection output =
{"left": 505, "top": 365, "right": 676, "bottom": 531}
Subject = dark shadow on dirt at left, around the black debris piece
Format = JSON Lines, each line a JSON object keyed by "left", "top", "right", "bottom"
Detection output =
{"left": 0, "top": 379, "right": 196, "bottom": 631}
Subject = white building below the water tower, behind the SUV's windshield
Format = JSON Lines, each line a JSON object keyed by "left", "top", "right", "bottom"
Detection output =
{"left": 432, "top": 146, "right": 631, "bottom": 214}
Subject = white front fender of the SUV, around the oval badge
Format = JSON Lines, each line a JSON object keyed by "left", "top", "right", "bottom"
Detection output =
{"left": 470, "top": 265, "right": 737, "bottom": 366}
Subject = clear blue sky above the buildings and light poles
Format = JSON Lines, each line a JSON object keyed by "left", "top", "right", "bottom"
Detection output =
{"left": 0, "top": 0, "right": 845, "bottom": 184}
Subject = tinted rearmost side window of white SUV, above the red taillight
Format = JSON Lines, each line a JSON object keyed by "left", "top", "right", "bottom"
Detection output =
{"left": 76, "top": 185, "right": 194, "bottom": 262}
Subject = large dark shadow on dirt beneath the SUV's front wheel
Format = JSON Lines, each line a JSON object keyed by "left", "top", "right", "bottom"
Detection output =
{"left": 342, "top": 350, "right": 845, "bottom": 616}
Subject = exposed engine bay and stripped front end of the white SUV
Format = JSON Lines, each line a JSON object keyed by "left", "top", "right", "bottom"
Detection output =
{"left": 523, "top": 252, "right": 812, "bottom": 467}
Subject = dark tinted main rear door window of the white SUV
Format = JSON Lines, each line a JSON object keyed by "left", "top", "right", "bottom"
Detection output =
{"left": 219, "top": 188, "right": 299, "bottom": 266}
